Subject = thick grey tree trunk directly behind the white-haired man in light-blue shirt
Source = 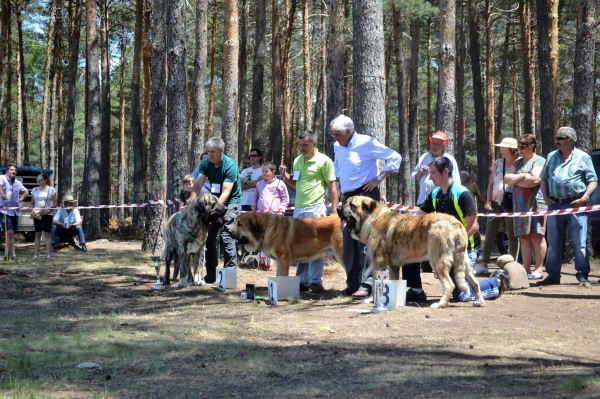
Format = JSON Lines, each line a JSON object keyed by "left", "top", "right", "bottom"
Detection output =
{"left": 352, "top": 0, "right": 387, "bottom": 197}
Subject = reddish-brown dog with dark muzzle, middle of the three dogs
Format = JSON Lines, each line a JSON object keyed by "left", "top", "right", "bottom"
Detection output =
{"left": 231, "top": 212, "right": 344, "bottom": 276}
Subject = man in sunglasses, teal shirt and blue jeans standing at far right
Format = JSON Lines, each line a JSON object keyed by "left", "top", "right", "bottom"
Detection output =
{"left": 538, "top": 127, "right": 598, "bottom": 288}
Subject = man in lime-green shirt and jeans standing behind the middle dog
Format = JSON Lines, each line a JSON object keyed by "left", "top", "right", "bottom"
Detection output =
{"left": 281, "top": 130, "right": 338, "bottom": 294}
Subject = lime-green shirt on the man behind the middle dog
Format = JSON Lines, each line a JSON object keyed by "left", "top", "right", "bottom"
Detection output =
{"left": 292, "top": 152, "right": 335, "bottom": 208}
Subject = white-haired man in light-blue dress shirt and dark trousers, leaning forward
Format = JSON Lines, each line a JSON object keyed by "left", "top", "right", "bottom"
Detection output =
{"left": 329, "top": 115, "right": 402, "bottom": 299}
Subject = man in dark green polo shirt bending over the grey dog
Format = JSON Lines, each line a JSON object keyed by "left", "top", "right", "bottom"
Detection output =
{"left": 190, "top": 137, "right": 242, "bottom": 284}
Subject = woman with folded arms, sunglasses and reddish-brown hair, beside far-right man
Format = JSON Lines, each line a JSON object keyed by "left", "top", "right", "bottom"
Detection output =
{"left": 504, "top": 134, "right": 546, "bottom": 280}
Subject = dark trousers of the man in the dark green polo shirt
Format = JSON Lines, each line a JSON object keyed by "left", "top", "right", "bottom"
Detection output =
{"left": 204, "top": 202, "right": 241, "bottom": 283}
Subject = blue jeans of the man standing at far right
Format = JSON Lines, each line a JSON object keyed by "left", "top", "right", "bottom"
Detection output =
{"left": 546, "top": 203, "right": 590, "bottom": 280}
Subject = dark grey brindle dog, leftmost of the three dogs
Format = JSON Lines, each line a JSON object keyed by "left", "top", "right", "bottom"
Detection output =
{"left": 164, "top": 194, "right": 227, "bottom": 288}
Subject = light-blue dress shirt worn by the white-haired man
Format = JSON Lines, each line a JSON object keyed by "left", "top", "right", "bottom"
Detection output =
{"left": 333, "top": 132, "right": 402, "bottom": 193}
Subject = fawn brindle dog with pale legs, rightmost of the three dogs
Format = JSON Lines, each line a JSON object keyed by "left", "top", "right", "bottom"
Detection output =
{"left": 338, "top": 196, "right": 485, "bottom": 308}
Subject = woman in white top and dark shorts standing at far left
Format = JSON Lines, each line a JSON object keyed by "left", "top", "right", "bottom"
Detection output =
{"left": 31, "top": 173, "right": 58, "bottom": 259}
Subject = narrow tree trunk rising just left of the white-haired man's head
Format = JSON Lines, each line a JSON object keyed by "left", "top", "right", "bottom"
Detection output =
{"left": 323, "top": 0, "right": 344, "bottom": 157}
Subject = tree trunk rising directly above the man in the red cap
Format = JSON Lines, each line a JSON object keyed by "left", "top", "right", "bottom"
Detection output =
{"left": 435, "top": 0, "right": 456, "bottom": 145}
